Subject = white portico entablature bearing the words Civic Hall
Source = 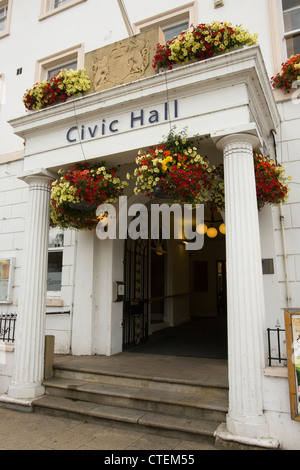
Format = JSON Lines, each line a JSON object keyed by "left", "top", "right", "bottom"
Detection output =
{"left": 10, "top": 46, "right": 279, "bottom": 171}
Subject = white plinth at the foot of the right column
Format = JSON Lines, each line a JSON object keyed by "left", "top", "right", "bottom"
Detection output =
{"left": 215, "top": 423, "right": 280, "bottom": 450}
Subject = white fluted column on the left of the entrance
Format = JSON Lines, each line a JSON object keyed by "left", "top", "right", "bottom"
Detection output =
{"left": 8, "top": 175, "right": 50, "bottom": 399}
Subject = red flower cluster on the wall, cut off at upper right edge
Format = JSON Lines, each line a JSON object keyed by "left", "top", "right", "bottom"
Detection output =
{"left": 271, "top": 54, "right": 300, "bottom": 93}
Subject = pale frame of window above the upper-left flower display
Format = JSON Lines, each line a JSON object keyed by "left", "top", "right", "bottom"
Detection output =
{"left": 35, "top": 44, "right": 84, "bottom": 82}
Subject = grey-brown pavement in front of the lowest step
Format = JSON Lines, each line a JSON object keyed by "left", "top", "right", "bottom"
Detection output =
{"left": 0, "top": 404, "right": 217, "bottom": 452}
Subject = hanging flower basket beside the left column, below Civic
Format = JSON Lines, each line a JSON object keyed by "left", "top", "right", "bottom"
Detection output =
{"left": 50, "top": 165, "right": 128, "bottom": 230}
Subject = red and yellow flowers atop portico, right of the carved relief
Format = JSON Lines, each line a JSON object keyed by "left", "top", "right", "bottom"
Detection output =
{"left": 153, "top": 21, "right": 258, "bottom": 70}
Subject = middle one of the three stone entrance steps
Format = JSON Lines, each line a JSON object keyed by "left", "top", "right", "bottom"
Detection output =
{"left": 44, "top": 377, "right": 228, "bottom": 422}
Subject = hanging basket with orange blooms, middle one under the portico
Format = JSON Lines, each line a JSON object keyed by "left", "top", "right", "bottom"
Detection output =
{"left": 130, "top": 126, "right": 214, "bottom": 205}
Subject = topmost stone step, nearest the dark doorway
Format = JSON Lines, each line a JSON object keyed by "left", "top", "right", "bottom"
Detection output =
{"left": 54, "top": 364, "right": 228, "bottom": 400}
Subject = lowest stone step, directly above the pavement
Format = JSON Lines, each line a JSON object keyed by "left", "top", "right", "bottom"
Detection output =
{"left": 34, "top": 395, "right": 219, "bottom": 445}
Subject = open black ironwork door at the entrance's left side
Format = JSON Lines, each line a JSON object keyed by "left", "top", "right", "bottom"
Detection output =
{"left": 123, "top": 238, "right": 149, "bottom": 348}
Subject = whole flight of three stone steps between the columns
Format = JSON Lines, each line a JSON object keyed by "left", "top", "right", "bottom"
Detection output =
{"left": 34, "top": 356, "right": 228, "bottom": 444}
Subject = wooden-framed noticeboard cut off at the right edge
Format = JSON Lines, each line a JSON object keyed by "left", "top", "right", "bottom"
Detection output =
{"left": 284, "top": 308, "right": 300, "bottom": 421}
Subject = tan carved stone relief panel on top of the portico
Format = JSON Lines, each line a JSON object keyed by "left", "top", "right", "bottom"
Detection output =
{"left": 85, "top": 29, "right": 161, "bottom": 93}
